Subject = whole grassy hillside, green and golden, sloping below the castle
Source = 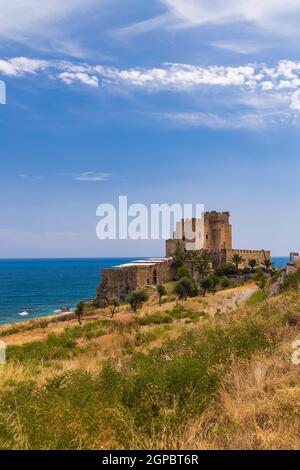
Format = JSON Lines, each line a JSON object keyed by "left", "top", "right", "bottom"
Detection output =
{"left": 0, "top": 285, "right": 300, "bottom": 449}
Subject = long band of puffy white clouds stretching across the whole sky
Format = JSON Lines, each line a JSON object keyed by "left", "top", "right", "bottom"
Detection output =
{"left": 0, "top": 57, "right": 300, "bottom": 131}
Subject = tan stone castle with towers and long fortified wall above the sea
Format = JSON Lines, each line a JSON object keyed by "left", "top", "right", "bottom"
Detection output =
{"left": 97, "top": 211, "right": 271, "bottom": 300}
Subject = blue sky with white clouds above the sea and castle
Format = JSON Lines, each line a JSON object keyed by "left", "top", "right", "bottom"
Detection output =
{"left": 0, "top": 0, "right": 300, "bottom": 257}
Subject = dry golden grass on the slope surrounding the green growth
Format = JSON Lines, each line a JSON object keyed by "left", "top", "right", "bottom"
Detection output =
{"left": 0, "top": 284, "right": 300, "bottom": 450}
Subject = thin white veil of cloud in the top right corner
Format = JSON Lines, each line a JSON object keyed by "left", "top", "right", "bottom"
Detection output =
{"left": 122, "top": 0, "right": 300, "bottom": 36}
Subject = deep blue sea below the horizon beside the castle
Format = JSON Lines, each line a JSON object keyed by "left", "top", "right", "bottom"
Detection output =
{"left": 0, "top": 257, "right": 289, "bottom": 325}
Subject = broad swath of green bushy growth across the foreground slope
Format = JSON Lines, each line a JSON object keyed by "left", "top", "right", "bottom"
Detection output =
{"left": 0, "top": 298, "right": 279, "bottom": 449}
